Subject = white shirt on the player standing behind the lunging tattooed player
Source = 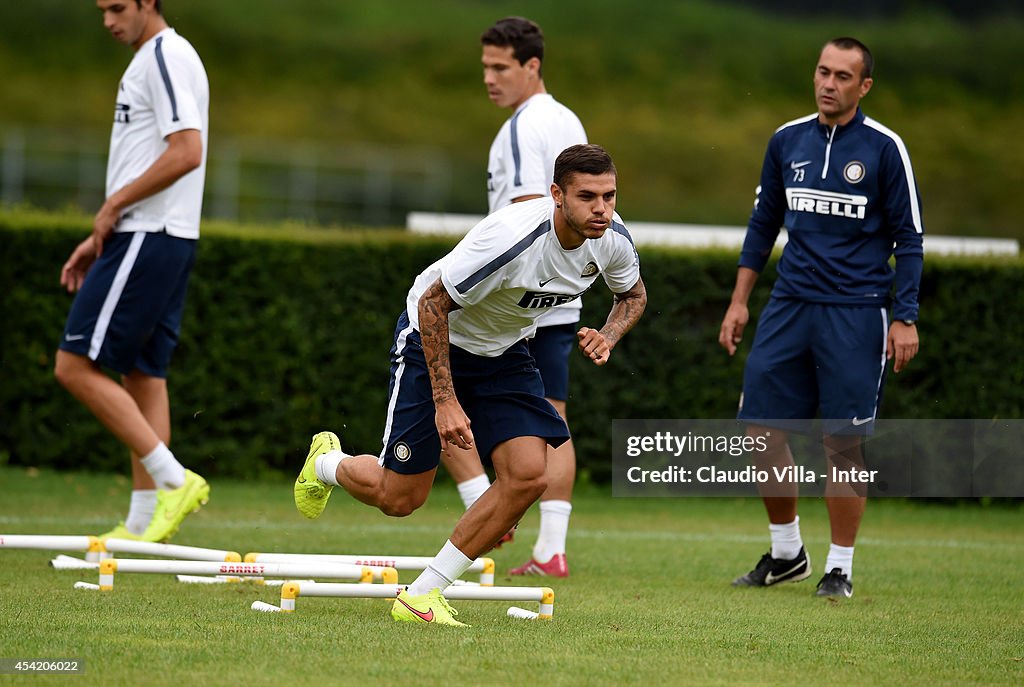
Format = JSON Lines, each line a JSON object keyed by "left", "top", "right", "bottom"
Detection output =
{"left": 487, "top": 93, "right": 587, "bottom": 327}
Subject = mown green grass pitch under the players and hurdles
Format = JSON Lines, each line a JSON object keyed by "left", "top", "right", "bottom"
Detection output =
{"left": 0, "top": 468, "right": 1024, "bottom": 685}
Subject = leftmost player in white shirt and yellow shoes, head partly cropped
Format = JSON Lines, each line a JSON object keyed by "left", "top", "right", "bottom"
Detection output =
{"left": 54, "top": 0, "right": 210, "bottom": 542}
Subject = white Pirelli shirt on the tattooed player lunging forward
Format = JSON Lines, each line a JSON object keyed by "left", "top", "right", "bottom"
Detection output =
{"left": 406, "top": 198, "right": 640, "bottom": 357}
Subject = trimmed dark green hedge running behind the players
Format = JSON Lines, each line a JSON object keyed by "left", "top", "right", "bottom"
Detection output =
{"left": 0, "top": 211, "right": 1024, "bottom": 481}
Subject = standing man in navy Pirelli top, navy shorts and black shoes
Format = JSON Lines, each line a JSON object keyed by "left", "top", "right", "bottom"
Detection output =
{"left": 719, "top": 38, "right": 924, "bottom": 597}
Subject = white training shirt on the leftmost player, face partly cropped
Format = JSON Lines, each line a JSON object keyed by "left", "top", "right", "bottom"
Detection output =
{"left": 106, "top": 29, "right": 210, "bottom": 239}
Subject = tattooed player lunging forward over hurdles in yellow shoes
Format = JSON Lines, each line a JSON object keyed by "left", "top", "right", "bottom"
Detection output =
{"left": 294, "top": 144, "right": 647, "bottom": 626}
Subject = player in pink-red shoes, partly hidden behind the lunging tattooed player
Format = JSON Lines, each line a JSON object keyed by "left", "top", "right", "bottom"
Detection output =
{"left": 441, "top": 16, "right": 587, "bottom": 577}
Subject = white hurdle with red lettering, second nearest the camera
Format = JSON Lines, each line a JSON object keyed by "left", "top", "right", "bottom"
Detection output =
{"left": 99, "top": 558, "right": 398, "bottom": 592}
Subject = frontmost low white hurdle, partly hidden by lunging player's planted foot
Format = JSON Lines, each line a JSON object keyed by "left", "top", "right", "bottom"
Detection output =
{"left": 260, "top": 581, "right": 555, "bottom": 620}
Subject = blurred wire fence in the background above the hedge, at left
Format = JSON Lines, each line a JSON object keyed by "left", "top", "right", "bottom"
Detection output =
{"left": 0, "top": 127, "right": 453, "bottom": 225}
